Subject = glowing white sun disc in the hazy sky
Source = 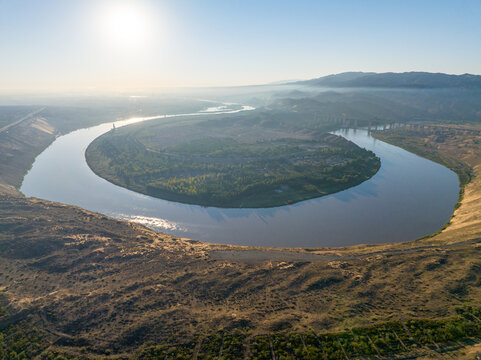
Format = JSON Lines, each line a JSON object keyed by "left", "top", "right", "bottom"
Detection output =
{"left": 96, "top": 1, "right": 152, "bottom": 50}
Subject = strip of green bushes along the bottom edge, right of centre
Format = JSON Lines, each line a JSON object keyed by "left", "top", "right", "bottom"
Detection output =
{"left": 134, "top": 307, "right": 481, "bottom": 360}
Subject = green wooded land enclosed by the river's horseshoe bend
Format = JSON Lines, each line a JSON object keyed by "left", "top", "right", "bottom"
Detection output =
{"left": 86, "top": 113, "right": 380, "bottom": 208}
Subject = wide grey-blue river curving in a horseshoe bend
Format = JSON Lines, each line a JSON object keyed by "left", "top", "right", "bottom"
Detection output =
{"left": 21, "top": 108, "right": 459, "bottom": 247}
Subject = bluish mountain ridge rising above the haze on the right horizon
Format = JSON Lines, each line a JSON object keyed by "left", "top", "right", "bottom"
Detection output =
{"left": 291, "top": 72, "right": 481, "bottom": 89}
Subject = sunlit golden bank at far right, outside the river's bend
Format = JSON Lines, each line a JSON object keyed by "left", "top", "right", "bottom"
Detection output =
{"left": 373, "top": 124, "right": 481, "bottom": 243}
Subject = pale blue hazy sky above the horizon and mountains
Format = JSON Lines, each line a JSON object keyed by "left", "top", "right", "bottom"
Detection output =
{"left": 0, "top": 0, "right": 481, "bottom": 92}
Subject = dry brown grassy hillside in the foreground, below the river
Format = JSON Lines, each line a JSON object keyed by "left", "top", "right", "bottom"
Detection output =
{"left": 0, "top": 117, "right": 481, "bottom": 359}
